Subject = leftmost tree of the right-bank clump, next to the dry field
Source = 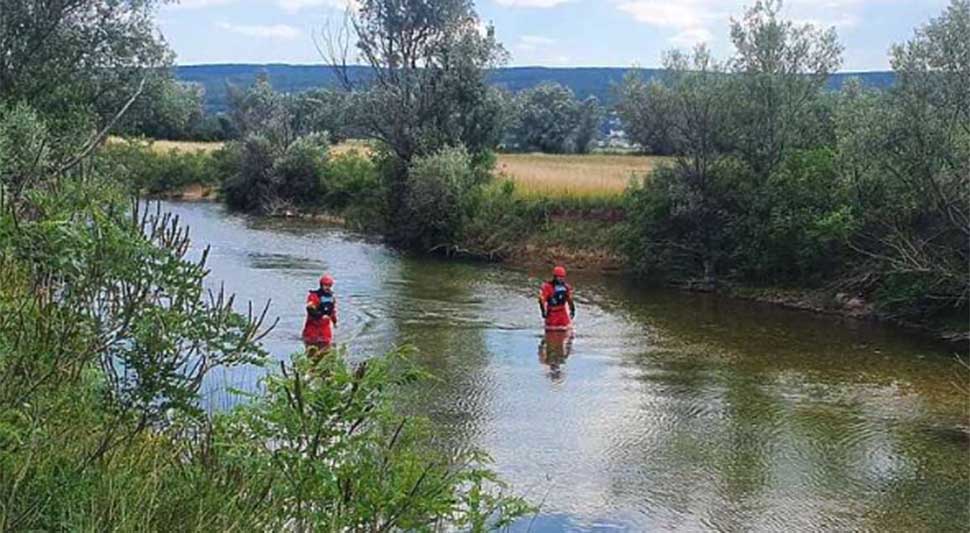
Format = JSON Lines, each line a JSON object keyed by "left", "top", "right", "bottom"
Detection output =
{"left": 629, "top": 45, "right": 737, "bottom": 285}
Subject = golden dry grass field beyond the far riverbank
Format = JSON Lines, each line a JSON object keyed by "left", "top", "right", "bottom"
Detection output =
{"left": 109, "top": 139, "right": 664, "bottom": 198}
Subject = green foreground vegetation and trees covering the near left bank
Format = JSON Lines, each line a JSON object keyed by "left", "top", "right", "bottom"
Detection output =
{"left": 0, "top": 0, "right": 527, "bottom": 531}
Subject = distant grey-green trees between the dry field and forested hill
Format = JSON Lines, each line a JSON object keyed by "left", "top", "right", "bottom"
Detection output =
{"left": 129, "top": 73, "right": 606, "bottom": 154}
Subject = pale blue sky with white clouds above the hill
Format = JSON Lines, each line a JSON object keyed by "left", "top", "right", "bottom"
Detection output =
{"left": 159, "top": 0, "right": 948, "bottom": 70}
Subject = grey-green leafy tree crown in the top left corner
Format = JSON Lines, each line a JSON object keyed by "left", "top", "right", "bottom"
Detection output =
{"left": 0, "top": 0, "right": 172, "bottom": 124}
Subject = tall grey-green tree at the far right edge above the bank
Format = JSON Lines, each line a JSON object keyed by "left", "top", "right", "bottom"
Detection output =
{"left": 839, "top": 0, "right": 970, "bottom": 315}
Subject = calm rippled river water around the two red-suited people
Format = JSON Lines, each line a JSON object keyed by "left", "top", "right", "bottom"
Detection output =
{"left": 164, "top": 203, "right": 970, "bottom": 531}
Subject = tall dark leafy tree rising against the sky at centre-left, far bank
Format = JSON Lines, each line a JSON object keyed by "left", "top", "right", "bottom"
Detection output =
{"left": 327, "top": 0, "right": 506, "bottom": 245}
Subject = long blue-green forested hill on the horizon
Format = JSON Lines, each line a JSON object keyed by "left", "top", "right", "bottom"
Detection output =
{"left": 176, "top": 64, "right": 893, "bottom": 111}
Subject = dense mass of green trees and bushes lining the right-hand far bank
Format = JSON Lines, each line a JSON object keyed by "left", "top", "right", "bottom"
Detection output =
{"left": 619, "top": 0, "right": 970, "bottom": 322}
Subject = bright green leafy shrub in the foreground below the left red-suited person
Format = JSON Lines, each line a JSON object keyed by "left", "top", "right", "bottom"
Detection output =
{"left": 215, "top": 353, "right": 527, "bottom": 531}
